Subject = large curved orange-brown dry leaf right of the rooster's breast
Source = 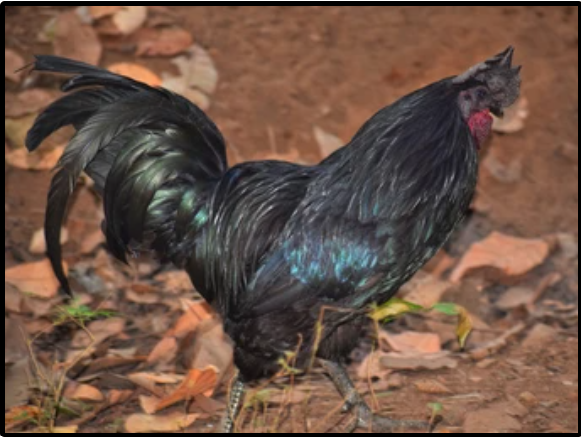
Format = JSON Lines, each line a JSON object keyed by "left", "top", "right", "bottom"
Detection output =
{"left": 452, "top": 232, "right": 551, "bottom": 283}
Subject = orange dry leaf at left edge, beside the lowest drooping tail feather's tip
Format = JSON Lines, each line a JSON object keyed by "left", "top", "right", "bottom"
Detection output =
{"left": 4, "top": 260, "right": 66, "bottom": 299}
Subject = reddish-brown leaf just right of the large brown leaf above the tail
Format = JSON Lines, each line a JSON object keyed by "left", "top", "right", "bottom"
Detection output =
{"left": 135, "top": 27, "right": 194, "bottom": 56}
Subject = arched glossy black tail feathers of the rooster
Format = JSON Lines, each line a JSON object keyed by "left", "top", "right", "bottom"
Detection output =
{"left": 27, "top": 56, "right": 227, "bottom": 294}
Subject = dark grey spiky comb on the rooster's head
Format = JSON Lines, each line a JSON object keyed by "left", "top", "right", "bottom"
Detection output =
{"left": 453, "top": 47, "right": 522, "bottom": 108}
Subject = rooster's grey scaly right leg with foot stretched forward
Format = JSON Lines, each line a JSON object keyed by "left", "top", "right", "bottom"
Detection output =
{"left": 321, "top": 360, "right": 430, "bottom": 433}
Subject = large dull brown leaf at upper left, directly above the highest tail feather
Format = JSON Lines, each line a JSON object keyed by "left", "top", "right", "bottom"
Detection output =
{"left": 54, "top": 11, "right": 103, "bottom": 65}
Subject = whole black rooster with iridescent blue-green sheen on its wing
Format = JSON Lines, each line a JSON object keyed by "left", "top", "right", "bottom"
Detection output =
{"left": 27, "top": 48, "right": 520, "bottom": 432}
